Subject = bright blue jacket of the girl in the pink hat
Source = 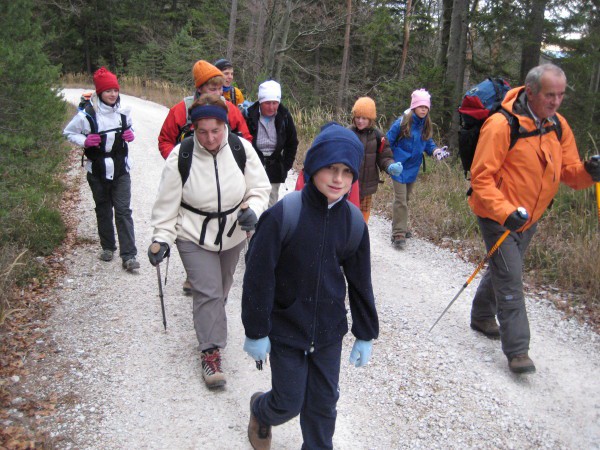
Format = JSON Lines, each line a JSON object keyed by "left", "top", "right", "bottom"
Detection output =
{"left": 387, "top": 114, "right": 437, "bottom": 183}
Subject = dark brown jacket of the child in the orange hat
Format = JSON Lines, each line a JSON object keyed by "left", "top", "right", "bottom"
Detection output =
{"left": 348, "top": 125, "right": 394, "bottom": 198}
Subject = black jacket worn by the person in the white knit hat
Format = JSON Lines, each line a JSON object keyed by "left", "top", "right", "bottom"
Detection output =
{"left": 246, "top": 102, "right": 298, "bottom": 183}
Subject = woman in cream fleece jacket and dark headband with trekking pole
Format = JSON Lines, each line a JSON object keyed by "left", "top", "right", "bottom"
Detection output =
{"left": 148, "top": 94, "right": 271, "bottom": 388}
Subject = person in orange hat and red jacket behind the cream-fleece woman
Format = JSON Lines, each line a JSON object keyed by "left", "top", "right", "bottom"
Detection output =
{"left": 158, "top": 60, "right": 252, "bottom": 159}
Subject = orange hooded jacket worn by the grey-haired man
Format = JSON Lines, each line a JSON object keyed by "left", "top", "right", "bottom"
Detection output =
{"left": 469, "top": 86, "right": 593, "bottom": 231}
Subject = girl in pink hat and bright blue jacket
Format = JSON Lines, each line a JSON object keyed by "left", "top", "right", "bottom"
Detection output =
{"left": 387, "top": 89, "right": 450, "bottom": 249}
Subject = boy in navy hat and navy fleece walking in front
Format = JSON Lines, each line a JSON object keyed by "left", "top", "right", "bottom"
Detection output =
{"left": 242, "top": 123, "right": 379, "bottom": 449}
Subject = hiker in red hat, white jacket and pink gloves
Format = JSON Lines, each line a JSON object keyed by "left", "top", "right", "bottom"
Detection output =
{"left": 63, "top": 67, "right": 140, "bottom": 272}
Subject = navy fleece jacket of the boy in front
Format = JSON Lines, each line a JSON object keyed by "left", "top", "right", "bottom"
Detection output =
{"left": 242, "top": 181, "right": 379, "bottom": 351}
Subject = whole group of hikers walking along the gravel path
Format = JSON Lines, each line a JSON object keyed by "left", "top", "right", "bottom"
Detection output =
{"left": 64, "top": 59, "right": 600, "bottom": 449}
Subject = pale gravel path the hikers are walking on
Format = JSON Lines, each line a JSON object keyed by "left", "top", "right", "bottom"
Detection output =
{"left": 10, "top": 89, "right": 600, "bottom": 449}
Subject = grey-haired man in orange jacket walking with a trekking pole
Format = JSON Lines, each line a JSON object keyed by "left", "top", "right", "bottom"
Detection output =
{"left": 469, "top": 64, "right": 600, "bottom": 373}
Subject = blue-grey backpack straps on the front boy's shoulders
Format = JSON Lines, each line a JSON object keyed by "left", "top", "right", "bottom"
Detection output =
{"left": 279, "top": 191, "right": 365, "bottom": 259}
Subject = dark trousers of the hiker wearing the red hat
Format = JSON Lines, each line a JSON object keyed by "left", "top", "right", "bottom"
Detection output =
{"left": 87, "top": 172, "right": 137, "bottom": 261}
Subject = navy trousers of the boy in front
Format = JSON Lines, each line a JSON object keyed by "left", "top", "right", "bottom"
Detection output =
{"left": 253, "top": 340, "right": 342, "bottom": 449}
